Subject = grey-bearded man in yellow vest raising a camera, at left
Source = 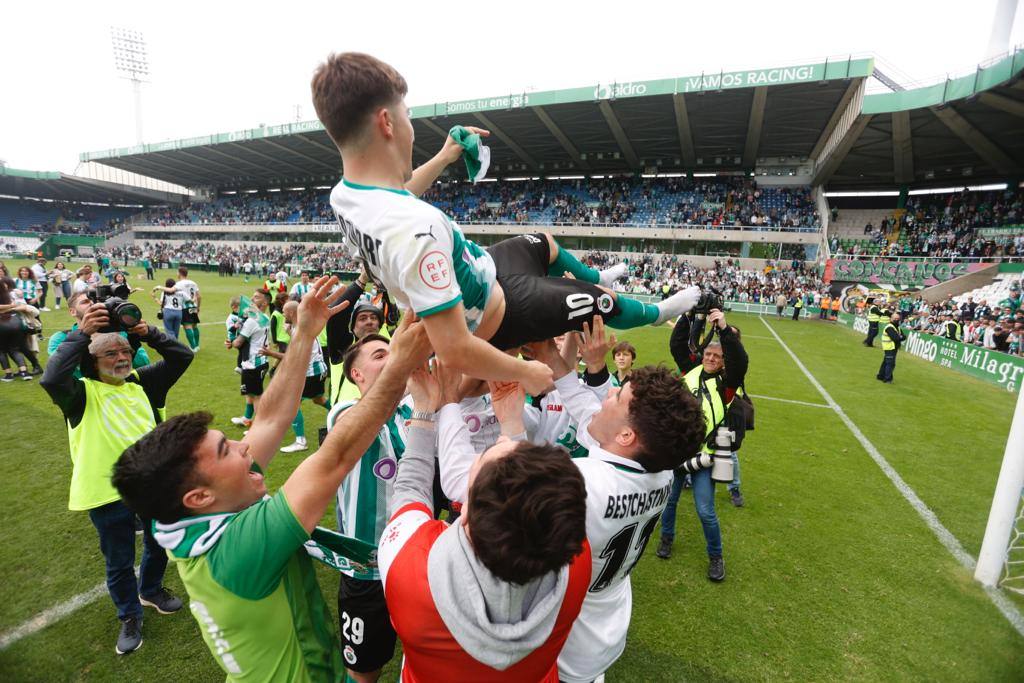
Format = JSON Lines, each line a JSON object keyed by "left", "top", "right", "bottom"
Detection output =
{"left": 40, "top": 303, "right": 194, "bottom": 654}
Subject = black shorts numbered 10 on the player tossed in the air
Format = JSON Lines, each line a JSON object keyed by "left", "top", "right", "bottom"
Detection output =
{"left": 487, "top": 232, "right": 618, "bottom": 350}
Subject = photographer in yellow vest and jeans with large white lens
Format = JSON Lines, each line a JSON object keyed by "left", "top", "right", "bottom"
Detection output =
{"left": 656, "top": 299, "right": 752, "bottom": 582}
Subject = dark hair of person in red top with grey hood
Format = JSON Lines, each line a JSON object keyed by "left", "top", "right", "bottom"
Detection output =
{"left": 466, "top": 441, "right": 587, "bottom": 586}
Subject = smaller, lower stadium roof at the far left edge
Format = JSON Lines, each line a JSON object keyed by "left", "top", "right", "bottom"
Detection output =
{"left": 0, "top": 166, "right": 184, "bottom": 204}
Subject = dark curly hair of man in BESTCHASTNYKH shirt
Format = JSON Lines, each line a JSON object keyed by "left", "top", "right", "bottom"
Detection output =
{"left": 629, "top": 366, "right": 705, "bottom": 472}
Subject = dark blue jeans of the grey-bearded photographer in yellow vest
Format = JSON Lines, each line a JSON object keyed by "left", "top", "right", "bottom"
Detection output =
{"left": 89, "top": 501, "right": 167, "bottom": 620}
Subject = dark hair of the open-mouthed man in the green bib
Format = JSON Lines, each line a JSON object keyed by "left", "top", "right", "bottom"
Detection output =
{"left": 111, "top": 412, "right": 213, "bottom": 524}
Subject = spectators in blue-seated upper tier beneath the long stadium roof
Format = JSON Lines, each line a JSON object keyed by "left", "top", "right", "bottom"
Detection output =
{"left": 128, "top": 177, "right": 820, "bottom": 230}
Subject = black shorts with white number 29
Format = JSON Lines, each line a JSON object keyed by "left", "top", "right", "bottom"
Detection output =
{"left": 338, "top": 574, "right": 397, "bottom": 674}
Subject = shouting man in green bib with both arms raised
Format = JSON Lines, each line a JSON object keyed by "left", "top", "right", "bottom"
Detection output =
{"left": 114, "top": 278, "right": 430, "bottom": 682}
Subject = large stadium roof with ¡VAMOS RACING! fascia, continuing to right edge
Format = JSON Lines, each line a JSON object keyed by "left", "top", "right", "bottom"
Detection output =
{"left": 81, "top": 52, "right": 1024, "bottom": 189}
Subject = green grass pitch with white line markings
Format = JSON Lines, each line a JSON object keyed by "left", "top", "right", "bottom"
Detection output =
{"left": 0, "top": 263, "right": 1024, "bottom": 682}
